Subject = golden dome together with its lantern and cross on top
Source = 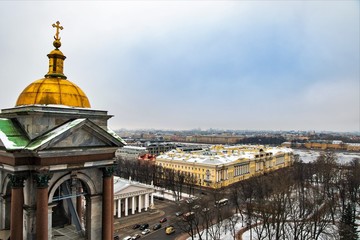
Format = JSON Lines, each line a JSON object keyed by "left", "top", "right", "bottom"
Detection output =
{"left": 16, "top": 22, "right": 90, "bottom": 108}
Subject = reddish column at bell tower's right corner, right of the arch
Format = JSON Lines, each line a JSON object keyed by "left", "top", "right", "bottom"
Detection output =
{"left": 102, "top": 166, "right": 114, "bottom": 240}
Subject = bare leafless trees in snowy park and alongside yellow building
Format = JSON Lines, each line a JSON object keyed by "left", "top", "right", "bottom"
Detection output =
{"left": 117, "top": 152, "right": 360, "bottom": 240}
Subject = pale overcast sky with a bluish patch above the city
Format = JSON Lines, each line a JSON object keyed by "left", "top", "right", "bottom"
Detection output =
{"left": 0, "top": 0, "right": 360, "bottom": 131}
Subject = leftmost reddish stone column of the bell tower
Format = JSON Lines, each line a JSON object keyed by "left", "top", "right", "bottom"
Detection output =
{"left": 9, "top": 174, "right": 26, "bottom": 240}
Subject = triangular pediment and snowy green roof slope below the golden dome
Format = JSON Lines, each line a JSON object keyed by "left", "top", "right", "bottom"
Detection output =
{"left": 0, "top": 118, "right": 126, "bottom": 151}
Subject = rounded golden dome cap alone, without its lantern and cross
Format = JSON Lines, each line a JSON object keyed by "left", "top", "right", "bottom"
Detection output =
{"left": 16, "top": 78, "right": 90, "bottom": 108}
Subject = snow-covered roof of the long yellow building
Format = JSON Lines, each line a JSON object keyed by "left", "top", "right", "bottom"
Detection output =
{"left": 156, "top": 145, "right": 293, "bottom": 165}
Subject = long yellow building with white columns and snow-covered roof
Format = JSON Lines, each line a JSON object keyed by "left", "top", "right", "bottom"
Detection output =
{"left": 156, "top": 145, "right": 293, "bottom": 188}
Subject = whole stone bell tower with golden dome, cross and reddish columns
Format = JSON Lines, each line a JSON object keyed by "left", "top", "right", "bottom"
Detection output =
{"left": 0, "top": 22, "right": 126, "bottom": 240}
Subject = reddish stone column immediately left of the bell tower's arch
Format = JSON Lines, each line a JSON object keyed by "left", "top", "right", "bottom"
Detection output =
{"left": 34, "top": 173, "right": 52, "bottom": 240}
